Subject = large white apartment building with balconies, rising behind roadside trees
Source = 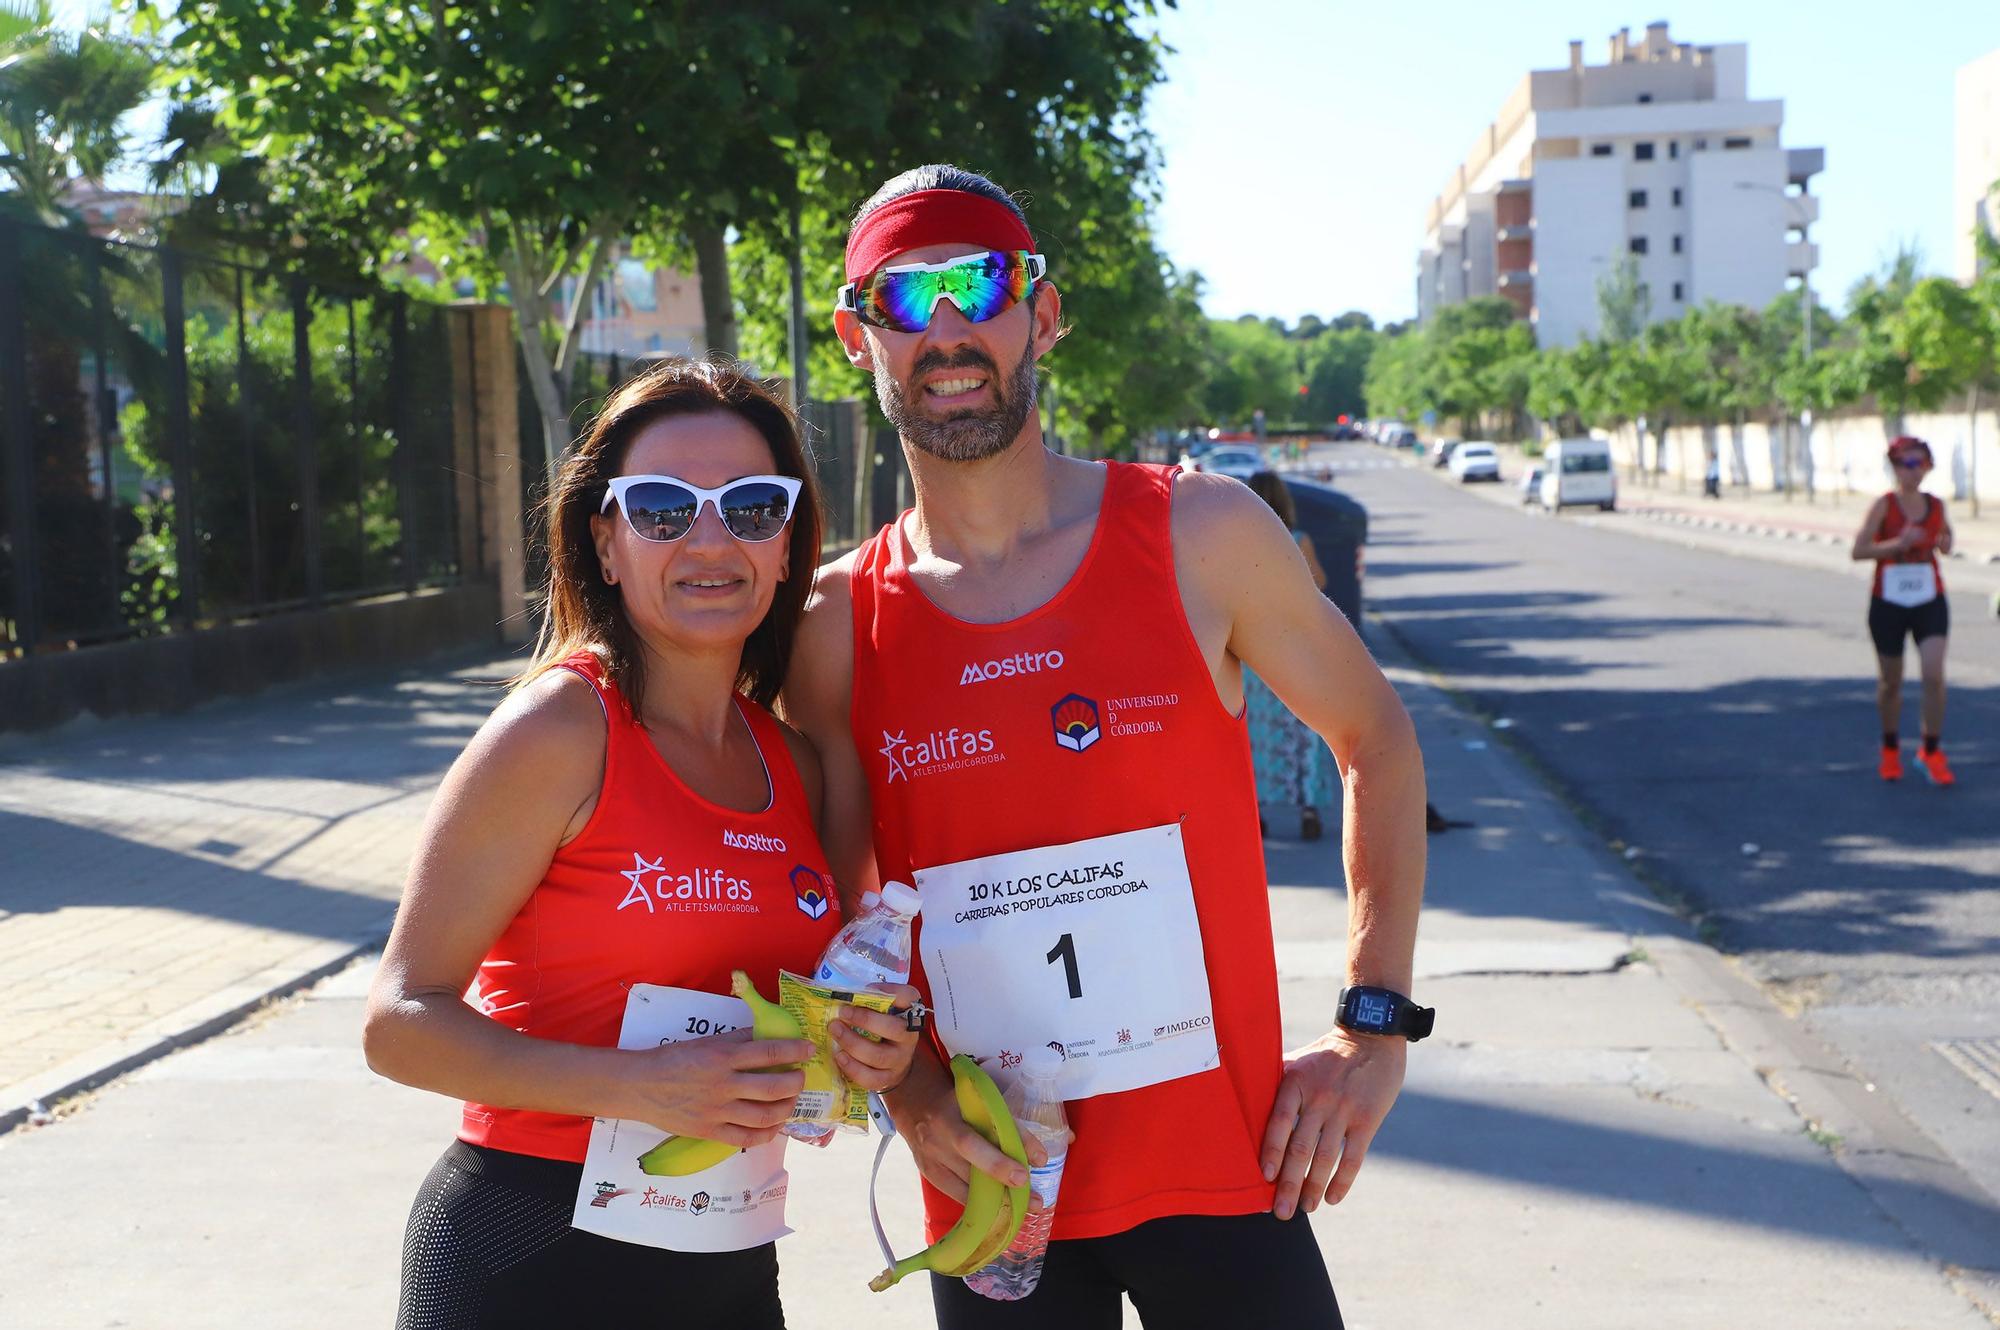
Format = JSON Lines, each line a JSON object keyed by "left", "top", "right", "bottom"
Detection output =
{"left": 1416, "top": 22, "right": 1826, "bottom": 346}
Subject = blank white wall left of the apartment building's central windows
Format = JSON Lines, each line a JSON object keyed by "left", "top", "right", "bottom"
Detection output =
{"left": 1534, "top": 156, "right": 1626, "bottom": 346}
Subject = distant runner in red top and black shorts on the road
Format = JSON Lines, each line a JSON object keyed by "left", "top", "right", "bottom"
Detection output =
{"left": 1854, "top": 434, "right": 1952, "bottom": 786}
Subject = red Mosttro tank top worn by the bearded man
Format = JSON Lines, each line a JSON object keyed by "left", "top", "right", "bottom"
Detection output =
{"left": 852, "top": 462, "right": 1284, "bottom": 1238}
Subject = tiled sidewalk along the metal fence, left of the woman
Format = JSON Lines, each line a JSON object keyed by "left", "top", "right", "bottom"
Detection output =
{"left": 0, "top": 656, "right": 514, "bottom": 1132}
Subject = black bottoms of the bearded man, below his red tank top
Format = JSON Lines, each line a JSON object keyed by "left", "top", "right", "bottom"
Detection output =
{"left": 930, "top": 1214, "right": 1340, "bottom": 1330}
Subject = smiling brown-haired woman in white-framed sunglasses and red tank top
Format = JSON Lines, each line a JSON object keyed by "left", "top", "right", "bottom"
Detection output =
{"left": 364, "top": 362, "right": 916, "bottom": 1330}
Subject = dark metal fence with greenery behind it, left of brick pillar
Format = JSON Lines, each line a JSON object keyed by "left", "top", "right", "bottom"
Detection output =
{"left": 0, "top": 222, "right": 460, "bottom": 660}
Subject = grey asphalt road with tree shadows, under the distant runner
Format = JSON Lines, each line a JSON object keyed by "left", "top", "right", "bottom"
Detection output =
{"left": 1304, "top": 446, "right": 2000, "bottom": 1196}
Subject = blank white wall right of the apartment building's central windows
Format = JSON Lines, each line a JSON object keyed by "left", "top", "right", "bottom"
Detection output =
{"left": 1684, "top": 140, "right": 1786, "bottom": 310}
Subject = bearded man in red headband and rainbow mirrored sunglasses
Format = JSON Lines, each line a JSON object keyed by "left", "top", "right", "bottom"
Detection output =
{"left": 786, "top": 166, "right": 1430, "bottom": 1328}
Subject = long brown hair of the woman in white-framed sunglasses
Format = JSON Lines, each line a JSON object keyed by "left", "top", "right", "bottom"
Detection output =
{"left": 514, "top": 360, "right": 820, "bottom": 716}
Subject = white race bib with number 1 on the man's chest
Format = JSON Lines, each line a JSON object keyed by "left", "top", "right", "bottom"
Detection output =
{"left": 916, "top": 822, "right": 1220, "bottom": 1100}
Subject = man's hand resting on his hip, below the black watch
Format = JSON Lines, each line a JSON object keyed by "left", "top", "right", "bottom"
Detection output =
{"left": 1264, "top": 1030, "right": 1410, "bottom": 1220}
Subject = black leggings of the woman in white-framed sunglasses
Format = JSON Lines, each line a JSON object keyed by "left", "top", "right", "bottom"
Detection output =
{"left": 396, "top": 1140, "right": 784, "bottom": 1330}
